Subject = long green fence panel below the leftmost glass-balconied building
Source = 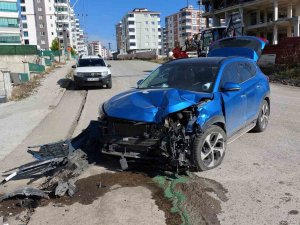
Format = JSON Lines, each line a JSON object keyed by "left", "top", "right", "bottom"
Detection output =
{"left": 0, "top": 45, "right": 38, "bottom": 55}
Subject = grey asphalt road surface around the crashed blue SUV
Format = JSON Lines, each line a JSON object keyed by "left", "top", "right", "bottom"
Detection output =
{"left": 0, "top": 61, "right": 300, "bottom": 225}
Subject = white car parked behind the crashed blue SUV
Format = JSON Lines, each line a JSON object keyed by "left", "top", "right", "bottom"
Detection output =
{"left": 72, "top": 56, "right": 112, "bottom": 89}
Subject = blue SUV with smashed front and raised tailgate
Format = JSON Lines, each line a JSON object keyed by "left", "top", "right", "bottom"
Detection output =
{"left": 99, "top": 36, "right": 270, "bottom": 171}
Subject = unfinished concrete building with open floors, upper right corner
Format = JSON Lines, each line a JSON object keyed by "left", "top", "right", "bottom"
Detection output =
{"left": 202, "top": 0, "right": 300, "bottom": 44}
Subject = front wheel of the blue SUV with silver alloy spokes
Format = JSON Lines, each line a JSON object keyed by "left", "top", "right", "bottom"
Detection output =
{"left": 193, "top": 125, "right": 227, "bottom": 171}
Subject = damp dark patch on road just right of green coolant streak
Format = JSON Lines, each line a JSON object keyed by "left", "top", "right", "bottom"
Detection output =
{"left": 177, "top": 176, "right": 228, "bottom": 225}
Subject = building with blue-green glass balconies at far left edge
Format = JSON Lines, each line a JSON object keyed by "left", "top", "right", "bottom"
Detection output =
{"left": 0, "top": 0, "right": 21, "bottom": 45}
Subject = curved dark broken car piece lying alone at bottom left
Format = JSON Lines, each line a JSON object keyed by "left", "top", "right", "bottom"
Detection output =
{"left": 0, "top": 187, "right": 49, "bottom": 202}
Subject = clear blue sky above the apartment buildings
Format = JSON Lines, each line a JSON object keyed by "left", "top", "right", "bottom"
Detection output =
{"left": 71, "top": 0, "right": 199, "bottom": 50}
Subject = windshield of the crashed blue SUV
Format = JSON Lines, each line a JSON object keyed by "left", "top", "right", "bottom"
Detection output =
{"left": 138, "top": 63, "right": 219, "bottom": 93}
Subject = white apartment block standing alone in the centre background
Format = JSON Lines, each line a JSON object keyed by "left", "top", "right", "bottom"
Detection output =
{"left": 122, "top": 8, "right": 161, "bottom": 53}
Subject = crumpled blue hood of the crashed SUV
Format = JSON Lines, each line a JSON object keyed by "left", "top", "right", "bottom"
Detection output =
{"left": 103, "top": 88, "right": 213, "bottom": 123}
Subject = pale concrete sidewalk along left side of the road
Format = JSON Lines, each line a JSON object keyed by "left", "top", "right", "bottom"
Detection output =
{"left": 0, "top": 61, "right": 74, "bottom": 160}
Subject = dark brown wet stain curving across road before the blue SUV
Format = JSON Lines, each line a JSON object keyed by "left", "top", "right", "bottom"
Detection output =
{"left": 41, "top": 172, "right": 181, "bottom": 225}
